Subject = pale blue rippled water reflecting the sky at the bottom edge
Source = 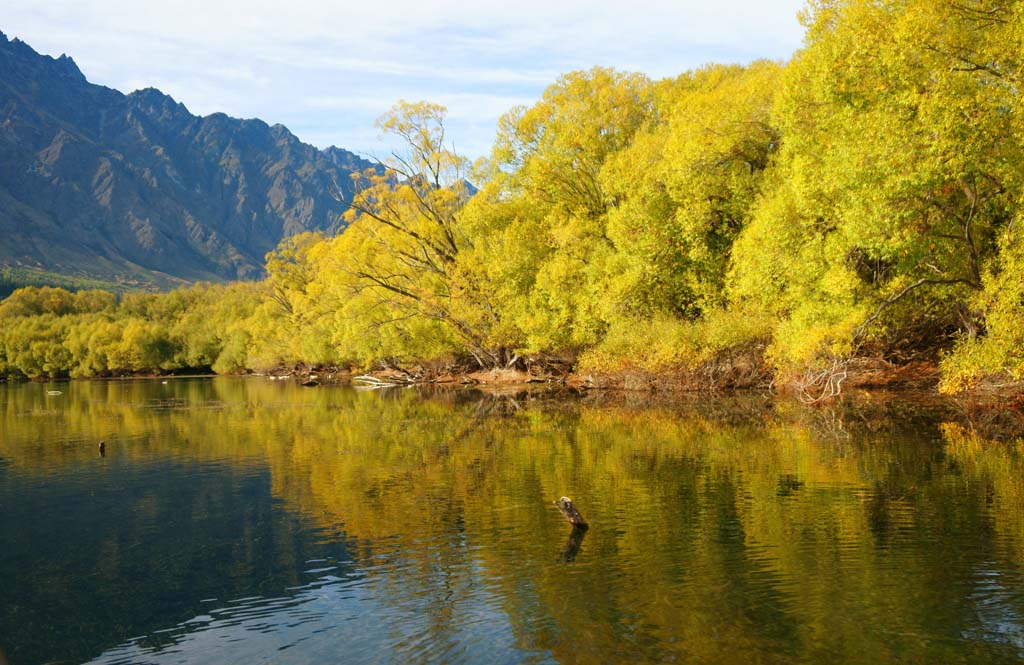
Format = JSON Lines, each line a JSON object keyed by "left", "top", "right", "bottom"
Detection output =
{"left": 91, "top": 561, "right": 543, "bottom": 665}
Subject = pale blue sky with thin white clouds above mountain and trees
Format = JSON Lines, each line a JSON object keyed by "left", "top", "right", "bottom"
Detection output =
{"left": 0, "top": 0, "right": 804, "bottom": 159}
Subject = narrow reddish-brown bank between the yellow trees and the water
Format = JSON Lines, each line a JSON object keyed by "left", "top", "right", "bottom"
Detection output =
{"left": 8, "top": 355, "right": 1024, "bottom": 414}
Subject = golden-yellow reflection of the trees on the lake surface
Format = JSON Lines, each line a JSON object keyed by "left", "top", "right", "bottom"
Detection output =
{"left": 0, "top": 379, "right": 1024, "bottom": 662}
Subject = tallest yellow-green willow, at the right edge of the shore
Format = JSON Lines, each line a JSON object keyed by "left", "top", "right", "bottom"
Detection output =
{"left": 730, "top": 0, "right": 1022, "bottom": 381}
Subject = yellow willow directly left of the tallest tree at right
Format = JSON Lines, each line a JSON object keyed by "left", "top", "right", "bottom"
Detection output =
{"left": 601, "top": 60, "right": 781, "bottom": 319}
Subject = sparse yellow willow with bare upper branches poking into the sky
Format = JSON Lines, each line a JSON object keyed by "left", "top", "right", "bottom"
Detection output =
{"left": 317, "top": 101, "right": 504, "bottom": 366}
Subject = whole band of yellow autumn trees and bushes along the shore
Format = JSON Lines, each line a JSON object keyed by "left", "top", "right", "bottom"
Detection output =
{"left": 0, "top": 0, "right": 1024, "bottom": 396}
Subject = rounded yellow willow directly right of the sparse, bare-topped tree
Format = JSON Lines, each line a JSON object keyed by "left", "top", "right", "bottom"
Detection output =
{"left": 468, "top": 68, "right": 654, "bottom": 351}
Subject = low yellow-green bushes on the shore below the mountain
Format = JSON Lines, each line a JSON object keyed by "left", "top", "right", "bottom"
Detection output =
{"left": 0, "top": 283, "right": 263, "bottom": 377}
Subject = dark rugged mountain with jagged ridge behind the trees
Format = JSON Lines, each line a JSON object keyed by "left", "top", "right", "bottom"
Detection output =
{"left": 0, "top": 33, "right": 372, "bottom": 286}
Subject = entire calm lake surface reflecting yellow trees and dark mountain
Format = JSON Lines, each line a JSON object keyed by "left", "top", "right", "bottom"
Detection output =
{"left": 0, "top": 379, "right": 1024, "bottom": 665}
